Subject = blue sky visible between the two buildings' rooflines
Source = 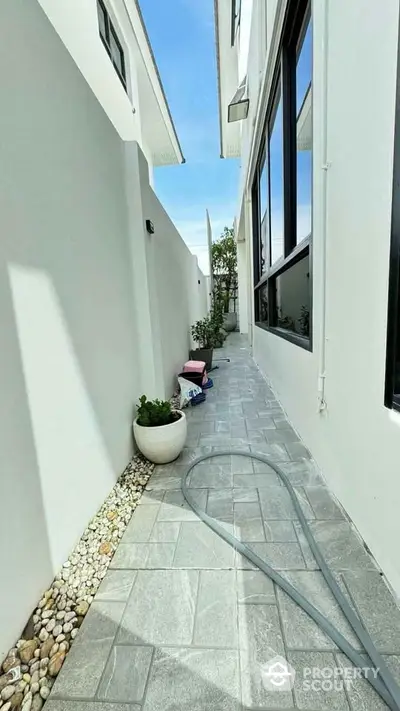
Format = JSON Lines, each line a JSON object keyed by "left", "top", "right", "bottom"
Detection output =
{"left": 140, "top": 0, "right": 239, "bottom": 271}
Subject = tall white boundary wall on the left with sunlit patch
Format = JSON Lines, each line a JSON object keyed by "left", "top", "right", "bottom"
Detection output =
{"left": 0, "top": 0, "right": 203, "bottom": 661}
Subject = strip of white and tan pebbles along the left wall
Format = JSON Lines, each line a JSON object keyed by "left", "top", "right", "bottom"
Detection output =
{"left": 0, "top": 455, "right": 154, "bottom": 711}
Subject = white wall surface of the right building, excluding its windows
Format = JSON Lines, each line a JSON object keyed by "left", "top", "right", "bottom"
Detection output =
{"left": 242, "top": 0, "right": 400, "bottom": 593}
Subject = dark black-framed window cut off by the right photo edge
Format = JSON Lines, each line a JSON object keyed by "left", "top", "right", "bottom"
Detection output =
{"left": 385, "top": 16, "right": 400, "bottom": 410}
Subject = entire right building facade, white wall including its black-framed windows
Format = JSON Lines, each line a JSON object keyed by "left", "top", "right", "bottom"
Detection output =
{"left": 215, "top": 0, "right": 400, "bottom": 594}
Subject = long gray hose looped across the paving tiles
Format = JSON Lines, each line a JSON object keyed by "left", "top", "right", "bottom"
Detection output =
{"left": 181, "top": 449, "right": 400, "bottom": 711}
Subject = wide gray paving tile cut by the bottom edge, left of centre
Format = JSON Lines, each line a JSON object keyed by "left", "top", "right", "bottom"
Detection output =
{"left": 143, "top": 648, "right": 241, "bottom": 711}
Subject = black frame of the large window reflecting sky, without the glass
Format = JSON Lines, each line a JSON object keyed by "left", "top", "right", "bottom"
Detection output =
{"left": 251, "top": 0, "right": 313, "bottom": 351}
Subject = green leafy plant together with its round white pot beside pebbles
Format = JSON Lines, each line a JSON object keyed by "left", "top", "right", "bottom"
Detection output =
{"left": 133, "top": 395, "right": 187, "bottom": 464}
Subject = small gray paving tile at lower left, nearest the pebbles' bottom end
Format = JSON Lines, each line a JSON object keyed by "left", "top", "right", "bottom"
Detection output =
{"left": 97, "top": 645, "right": 153, "bottom": 703}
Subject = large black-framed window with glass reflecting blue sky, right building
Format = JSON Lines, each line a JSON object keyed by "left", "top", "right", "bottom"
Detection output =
{"left": 252, "top": 0, "right": 312, "bottom": 350}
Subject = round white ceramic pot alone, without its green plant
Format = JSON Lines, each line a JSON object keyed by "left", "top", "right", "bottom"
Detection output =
{"left": 133, "top": 410, "right": 187, "bottom": 464}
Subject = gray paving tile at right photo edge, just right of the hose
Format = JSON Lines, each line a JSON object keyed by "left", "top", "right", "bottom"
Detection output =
{"left": 343, "top": 570, "right": 400, "bottom": 653}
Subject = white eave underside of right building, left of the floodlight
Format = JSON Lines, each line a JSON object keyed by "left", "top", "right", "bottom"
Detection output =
{"left": 214, "top": 0, "right": 241, "bottom": 158}
